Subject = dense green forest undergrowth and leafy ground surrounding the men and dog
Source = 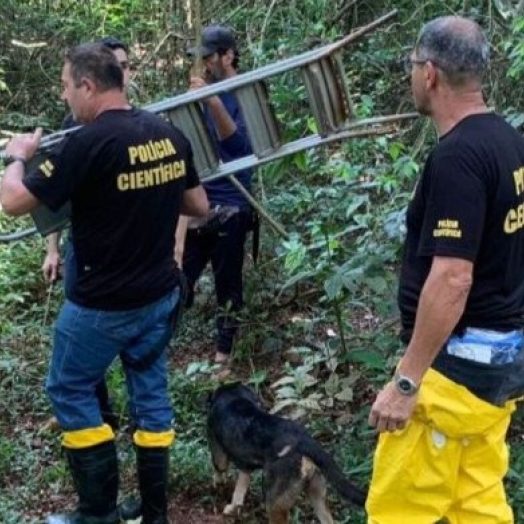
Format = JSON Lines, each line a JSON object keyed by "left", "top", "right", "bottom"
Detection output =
{"left": 0, "top": 0, "right": 524, "bottom": 524}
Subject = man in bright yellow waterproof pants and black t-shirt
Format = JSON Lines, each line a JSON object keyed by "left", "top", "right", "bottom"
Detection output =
{"left": 366, "top": 17, "right": 524, "bottom": 524}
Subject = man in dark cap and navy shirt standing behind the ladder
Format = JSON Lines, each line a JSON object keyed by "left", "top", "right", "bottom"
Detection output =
{"left": 175, "top": 25, "right": 254, "bottom": 375}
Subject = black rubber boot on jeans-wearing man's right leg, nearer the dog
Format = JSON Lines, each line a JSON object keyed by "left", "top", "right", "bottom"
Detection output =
{"left": 135, "top": 446, "right": 169, "bottom": 524}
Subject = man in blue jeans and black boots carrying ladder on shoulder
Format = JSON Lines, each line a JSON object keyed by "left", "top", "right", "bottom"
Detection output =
{"left": 0, "top": 44, "right": 209, "bottom": 524}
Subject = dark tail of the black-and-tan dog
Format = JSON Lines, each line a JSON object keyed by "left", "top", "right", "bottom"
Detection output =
{"left": 297, "top": 435, "right": 367, "bottom": 507}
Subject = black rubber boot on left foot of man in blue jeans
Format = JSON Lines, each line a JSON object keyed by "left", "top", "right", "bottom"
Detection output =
{"left": 47, "top": 441, "right": 120, "bottom": 524}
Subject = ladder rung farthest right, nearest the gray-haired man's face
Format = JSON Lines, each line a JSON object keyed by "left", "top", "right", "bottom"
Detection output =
{"left": 301, "top": 55, "right": 352, "bottom": 136}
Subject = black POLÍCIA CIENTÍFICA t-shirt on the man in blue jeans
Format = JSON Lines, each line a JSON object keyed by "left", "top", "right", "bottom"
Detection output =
{"left": 24, "top": 108, "right": 199, "bottom": 310}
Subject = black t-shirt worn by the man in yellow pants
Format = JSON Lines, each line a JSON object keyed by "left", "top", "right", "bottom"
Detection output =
{"left": 398, "top": 113, "right": 524, "bottom": 341}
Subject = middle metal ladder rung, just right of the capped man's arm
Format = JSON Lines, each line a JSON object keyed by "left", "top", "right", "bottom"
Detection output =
{"left": 234, "top": 81, "right": 281, "bottom": 158}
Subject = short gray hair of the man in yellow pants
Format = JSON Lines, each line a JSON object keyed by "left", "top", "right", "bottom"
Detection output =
{"left": 415, "top": 16, "right": 489, "bottom": 86}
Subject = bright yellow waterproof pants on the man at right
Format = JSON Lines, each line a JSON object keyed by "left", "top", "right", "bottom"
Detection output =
{"left": 366, "top": 369, "right": 515, "bottom": 524}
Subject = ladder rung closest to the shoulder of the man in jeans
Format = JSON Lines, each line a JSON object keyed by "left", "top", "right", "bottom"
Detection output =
{"left": 166, "top": 102, "right": 219, "bottom": 177}
